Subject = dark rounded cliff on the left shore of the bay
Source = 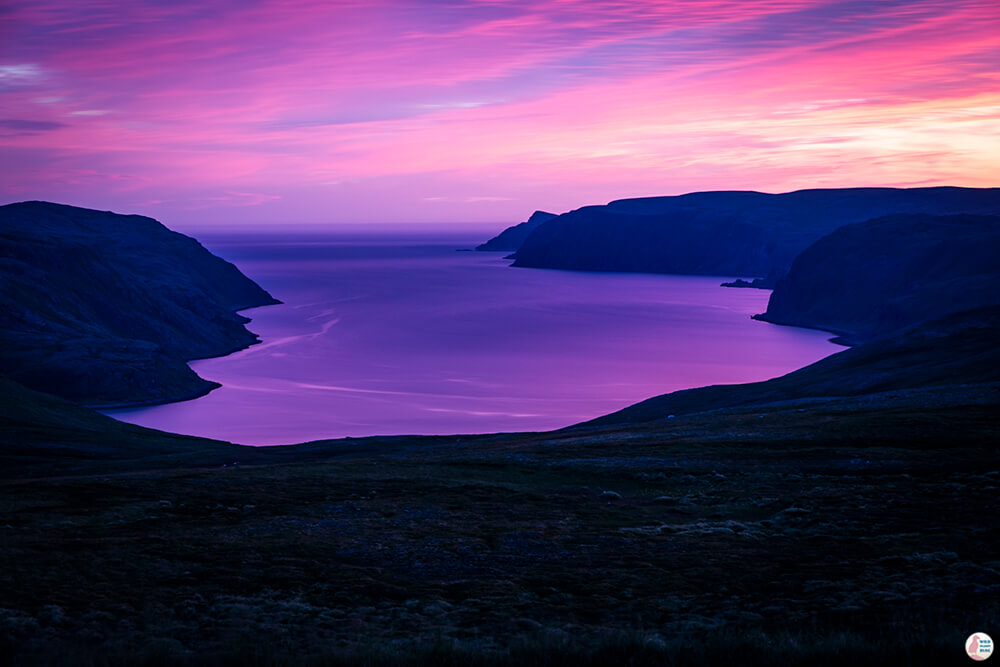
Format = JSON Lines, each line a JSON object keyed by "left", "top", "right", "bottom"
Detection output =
{"left": 0, "top": 202, "right": 277, "bottom": 406}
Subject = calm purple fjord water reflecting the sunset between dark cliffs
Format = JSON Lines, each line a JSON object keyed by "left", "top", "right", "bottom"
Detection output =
{"left": 109, "top": 228, "right": 841, "bottom": 445}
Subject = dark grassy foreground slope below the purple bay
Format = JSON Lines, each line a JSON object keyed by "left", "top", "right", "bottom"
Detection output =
{"left": 0, "top": 376, "right": 1000, "bottom": 665}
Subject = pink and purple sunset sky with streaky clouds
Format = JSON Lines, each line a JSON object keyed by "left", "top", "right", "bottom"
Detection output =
{"left": 0, "top": 0, "right": 1000, "bottom": 227}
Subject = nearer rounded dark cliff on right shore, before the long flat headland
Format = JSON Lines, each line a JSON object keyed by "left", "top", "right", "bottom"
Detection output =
{"left": 757, "top": 215, "right": 1000, "bottom": 341}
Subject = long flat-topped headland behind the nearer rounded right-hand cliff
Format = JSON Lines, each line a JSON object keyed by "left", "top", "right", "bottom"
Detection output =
{"left": 504, "top": 187, "right": 1000, "bottom": 284}
